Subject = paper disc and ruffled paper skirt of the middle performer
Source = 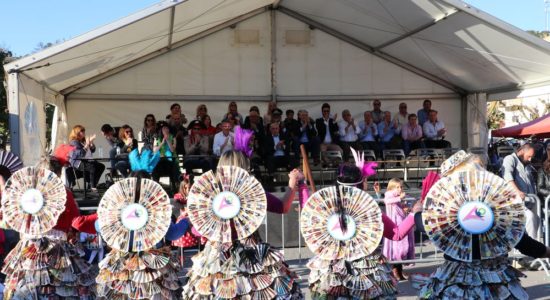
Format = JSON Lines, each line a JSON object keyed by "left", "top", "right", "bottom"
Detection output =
{"left": 183, "top": 166, "right": 303, "bottom": 299}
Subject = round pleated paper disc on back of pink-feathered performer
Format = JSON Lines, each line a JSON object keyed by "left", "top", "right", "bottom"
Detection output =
{"left": 300, "top": 186, "right": 384, "bottom": 260}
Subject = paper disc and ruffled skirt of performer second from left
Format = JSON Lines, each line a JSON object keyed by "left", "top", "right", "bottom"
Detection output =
{"left": 96, "top": 178, "right": 181, "bottom": 300}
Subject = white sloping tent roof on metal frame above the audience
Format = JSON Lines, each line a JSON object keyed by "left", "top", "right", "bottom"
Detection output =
{"left": 5, "top": 0, "right": 550, "bottom": 94}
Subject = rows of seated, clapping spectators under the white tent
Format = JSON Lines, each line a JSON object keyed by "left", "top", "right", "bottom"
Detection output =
{"left": 69, "top": 99, "right": 451, "bottom": 190}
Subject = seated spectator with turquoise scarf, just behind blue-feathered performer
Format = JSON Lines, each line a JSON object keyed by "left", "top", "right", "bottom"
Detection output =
{"left": 152, "top": 122, "right": 179, "bottom": 191}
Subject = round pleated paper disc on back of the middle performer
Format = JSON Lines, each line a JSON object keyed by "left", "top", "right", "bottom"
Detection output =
{"left": 187, "top": 166, "right": 267, "bottom": 243}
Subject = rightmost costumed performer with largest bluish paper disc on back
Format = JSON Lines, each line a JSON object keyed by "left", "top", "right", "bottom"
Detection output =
{"left": 413, "top": 151, "right": 550, "bottom": 299}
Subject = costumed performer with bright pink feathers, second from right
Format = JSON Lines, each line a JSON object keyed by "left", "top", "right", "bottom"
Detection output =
{"left": 300, "top": 148, "right": 408, "bottom": 300}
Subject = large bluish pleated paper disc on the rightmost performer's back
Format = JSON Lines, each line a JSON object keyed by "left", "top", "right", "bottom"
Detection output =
{"left": 422, "top": 171, "right": 525, "bottom": 261}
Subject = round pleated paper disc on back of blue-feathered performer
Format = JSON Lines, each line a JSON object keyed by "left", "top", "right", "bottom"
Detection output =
{"left": 97, "top": 178, "right": 172, "bottom": 252}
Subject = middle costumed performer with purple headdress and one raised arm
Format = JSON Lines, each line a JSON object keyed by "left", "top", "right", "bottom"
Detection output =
{"left": 183, "top": 127, "right": 305, "bottom": 299}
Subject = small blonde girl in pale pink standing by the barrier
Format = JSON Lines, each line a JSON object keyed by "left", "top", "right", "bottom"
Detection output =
{"left": 382, "top": 178, "right": 414, "bottom": 280}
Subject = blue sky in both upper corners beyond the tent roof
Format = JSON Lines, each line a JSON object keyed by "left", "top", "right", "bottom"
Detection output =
{"left": 0, "top": 0, "right": 545, "bottom": 56}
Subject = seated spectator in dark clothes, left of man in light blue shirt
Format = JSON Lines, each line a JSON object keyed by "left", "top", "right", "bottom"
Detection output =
{"left": 183, "top": 120, "right": 212, "bottom": 175}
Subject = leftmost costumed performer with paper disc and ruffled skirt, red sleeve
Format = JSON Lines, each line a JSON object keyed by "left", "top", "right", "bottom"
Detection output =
{"left": 2, "top": 159, "right": 95, "bottom": 299}
